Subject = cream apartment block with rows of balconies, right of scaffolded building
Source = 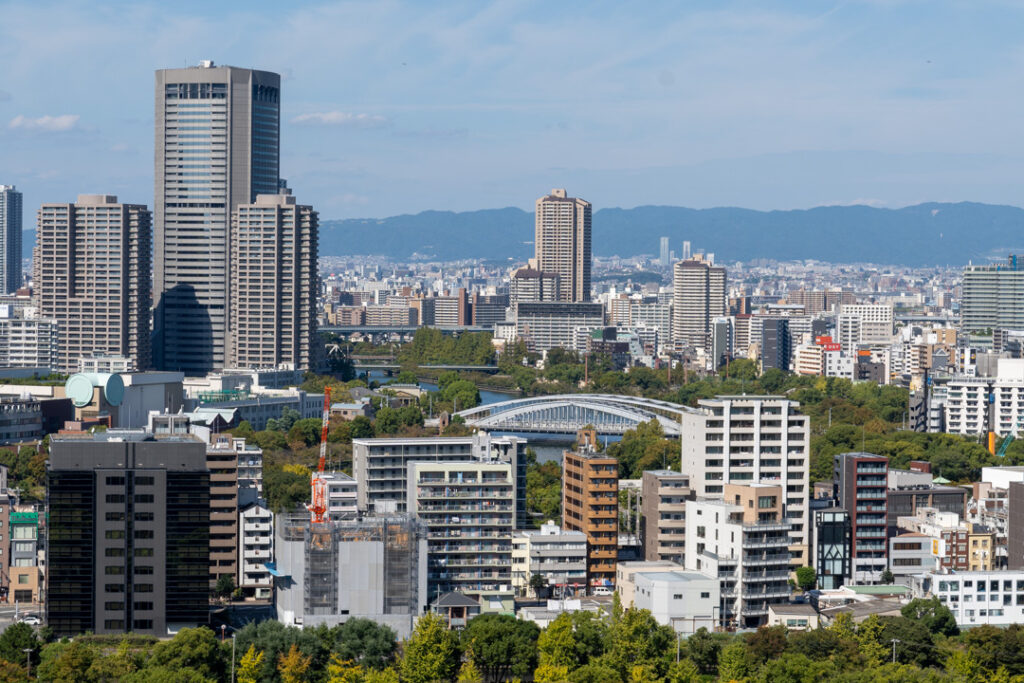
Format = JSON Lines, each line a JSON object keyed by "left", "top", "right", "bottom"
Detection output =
{"left": 407, "top": 461, "right": 516, "bottom": 610}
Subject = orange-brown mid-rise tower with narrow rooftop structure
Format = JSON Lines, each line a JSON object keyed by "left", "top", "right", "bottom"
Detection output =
{"left": 562, "top": 429, "right": 618, "bottom": 591}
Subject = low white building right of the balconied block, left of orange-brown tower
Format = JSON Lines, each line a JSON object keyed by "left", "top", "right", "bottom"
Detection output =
{"left": 512, "top": 520, "right": 587, "bottom": 598}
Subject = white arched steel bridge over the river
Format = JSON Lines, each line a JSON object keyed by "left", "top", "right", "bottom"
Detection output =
{"left": 458, "top": 393, "right": 695, "bottom": 436}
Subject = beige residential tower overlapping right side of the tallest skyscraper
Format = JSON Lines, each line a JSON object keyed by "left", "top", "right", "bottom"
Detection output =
{"left": 227, "top": 189, "right": 319, "bottom": 370}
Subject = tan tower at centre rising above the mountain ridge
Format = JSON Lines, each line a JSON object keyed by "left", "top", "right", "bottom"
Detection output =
{"left": 534, "top": 189, "right": 591, "bottom": 301}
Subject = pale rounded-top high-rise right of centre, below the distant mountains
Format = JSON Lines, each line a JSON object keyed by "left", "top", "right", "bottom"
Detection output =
{"left": 672, "top": 256, "right": 726, "bottom": 350}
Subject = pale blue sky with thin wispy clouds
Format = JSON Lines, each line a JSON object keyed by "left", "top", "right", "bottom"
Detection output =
{"left": 0, "top": 0, "right": 1024, "bottom": 219}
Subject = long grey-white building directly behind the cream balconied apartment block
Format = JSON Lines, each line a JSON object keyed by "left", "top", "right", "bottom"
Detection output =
{"left": 352, "top": 432, "right": 527, "bottom": 528}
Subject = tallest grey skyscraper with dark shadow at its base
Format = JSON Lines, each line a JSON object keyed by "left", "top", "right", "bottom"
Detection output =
{"left": 154, "top": 61, "right": 281, "bottom": 375}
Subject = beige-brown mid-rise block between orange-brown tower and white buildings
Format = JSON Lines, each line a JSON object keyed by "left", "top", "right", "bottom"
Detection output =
{"left": 640, "top": 470, "right": 691, "bottom": 564}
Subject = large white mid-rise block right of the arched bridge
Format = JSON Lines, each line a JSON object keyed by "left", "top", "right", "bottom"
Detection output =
{"left": 681, "top": 395, "right": 811, "bottom": 568}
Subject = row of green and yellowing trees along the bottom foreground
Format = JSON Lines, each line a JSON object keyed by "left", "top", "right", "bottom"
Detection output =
{"left": 9, "top": 597, "right": 1024, "bottom": 683}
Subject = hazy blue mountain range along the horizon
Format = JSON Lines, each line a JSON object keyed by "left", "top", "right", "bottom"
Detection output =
{"left": 24, "top": 202, "right": 1024, "bottom": 265}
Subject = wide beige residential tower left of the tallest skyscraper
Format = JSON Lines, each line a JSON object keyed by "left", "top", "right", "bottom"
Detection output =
{"left": 33, "top": 195, "right": 153, "bottom": 373}
